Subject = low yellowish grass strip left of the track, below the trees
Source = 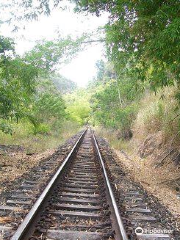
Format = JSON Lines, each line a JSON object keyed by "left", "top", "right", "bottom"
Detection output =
{"left": 0, "top": 121, "right": 79, "bottom": 153}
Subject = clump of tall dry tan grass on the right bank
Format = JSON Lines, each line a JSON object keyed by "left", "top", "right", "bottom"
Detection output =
{"left": 133, "top": 87, "right": 180, "bottom": 141}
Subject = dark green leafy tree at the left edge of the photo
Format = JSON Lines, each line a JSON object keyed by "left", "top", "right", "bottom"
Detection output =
{"left": 0, "top": 38, "right": 37, "bottom": 122}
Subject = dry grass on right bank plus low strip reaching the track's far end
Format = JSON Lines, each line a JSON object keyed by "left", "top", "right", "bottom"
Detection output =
{"left": 96, "top": 86, "right": 180, "bottom": 152}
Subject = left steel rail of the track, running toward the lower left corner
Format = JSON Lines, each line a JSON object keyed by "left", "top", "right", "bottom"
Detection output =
{"left": 11, "top": 130, "right": 87, "bottom": 240}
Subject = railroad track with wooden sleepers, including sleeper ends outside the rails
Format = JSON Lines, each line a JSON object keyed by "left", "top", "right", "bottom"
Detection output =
{"left": 0, "top": 129, "right": 176, "bottom": 240}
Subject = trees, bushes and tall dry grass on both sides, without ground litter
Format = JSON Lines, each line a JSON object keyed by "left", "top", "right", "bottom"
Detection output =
{"left": 0, "top": 0, "right": 180, "bottom": 160}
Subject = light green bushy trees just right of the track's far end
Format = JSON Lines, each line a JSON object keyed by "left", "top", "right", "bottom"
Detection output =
{"left": 89, "top": 58, "right": 142, "bottom": 132}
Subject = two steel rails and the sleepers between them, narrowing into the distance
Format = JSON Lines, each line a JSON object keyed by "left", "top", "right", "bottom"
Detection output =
{"left": 11, "top": 129, "right": 128, "bottom": 240}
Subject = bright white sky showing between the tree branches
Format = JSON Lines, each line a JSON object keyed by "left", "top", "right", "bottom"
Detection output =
{"left": 1, "top": 1, "right": 108, "bottom": 87}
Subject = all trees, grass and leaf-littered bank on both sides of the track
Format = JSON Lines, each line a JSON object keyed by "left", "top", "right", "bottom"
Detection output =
{"left": 0, "top": 0, "right": 180, "bottom": 232}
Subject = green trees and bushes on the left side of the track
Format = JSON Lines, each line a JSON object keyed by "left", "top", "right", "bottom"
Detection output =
{"left": 0, "top": 0, "right": 95, "bottom": 134}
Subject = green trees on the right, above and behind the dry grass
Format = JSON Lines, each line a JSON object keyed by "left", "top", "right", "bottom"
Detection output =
{"left": 70, "top": 0, "right": 180, "bottom": 135}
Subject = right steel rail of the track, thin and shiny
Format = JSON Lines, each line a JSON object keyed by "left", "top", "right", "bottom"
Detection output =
{"left": 92, "top": 133, "right": 128, "bottom": 240}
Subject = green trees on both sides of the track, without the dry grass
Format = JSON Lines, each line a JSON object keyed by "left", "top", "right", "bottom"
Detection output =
{"left": 0, "top": 0, "right": 180, "bottom": 137}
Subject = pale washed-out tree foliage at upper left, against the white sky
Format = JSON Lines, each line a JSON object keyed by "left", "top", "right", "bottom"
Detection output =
{"left": 25, "top": 36, "right": 85, "bottom": 75}
